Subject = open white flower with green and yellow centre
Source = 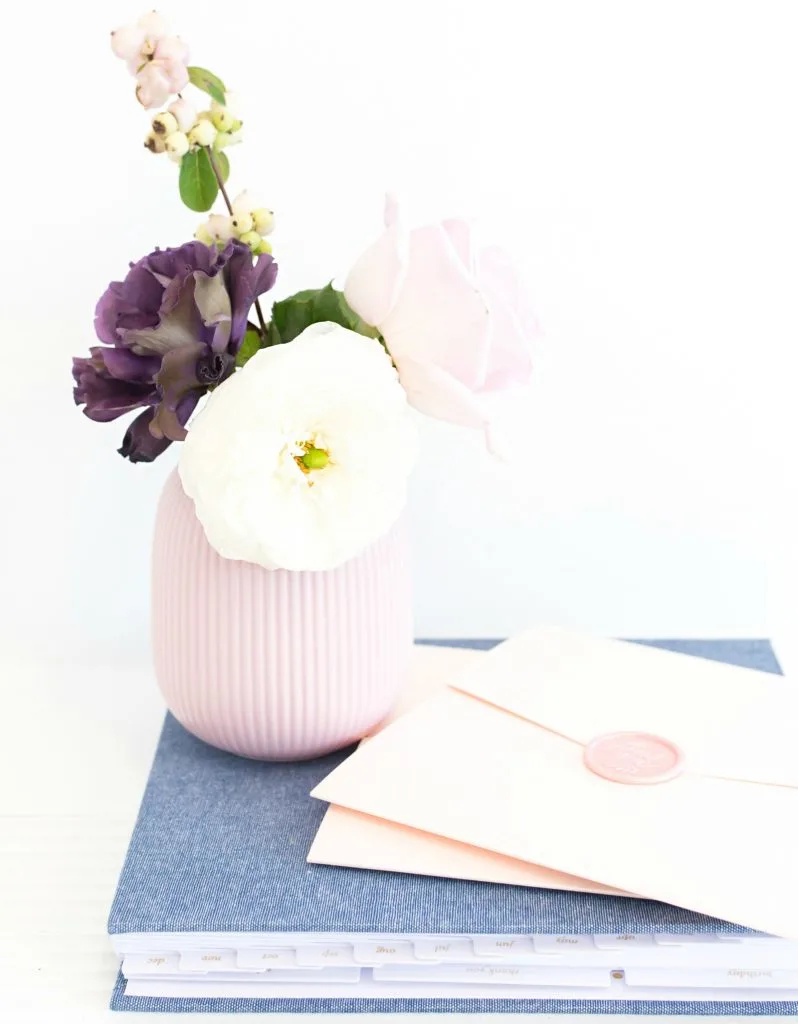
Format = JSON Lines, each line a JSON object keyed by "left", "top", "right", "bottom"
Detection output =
{"left": 179, "top": 324, "right": 416, "bottom": 569}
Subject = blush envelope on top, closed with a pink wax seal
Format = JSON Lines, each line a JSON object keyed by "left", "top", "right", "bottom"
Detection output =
{"left": 312, "top": 629, "right": 798, "bottom": 938}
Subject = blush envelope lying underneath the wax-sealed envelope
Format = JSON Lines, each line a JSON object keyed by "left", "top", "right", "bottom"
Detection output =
{"left": 307, "top": 646, "right": 627, "bottom": 895}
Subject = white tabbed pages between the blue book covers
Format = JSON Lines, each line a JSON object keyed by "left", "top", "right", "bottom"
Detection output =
{"left": 114, "top": 933, "right": 798, "bottom": 1001}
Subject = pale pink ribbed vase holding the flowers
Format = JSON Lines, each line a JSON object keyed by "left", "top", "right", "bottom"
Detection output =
{"left": 153, "top": 472, "right": 413, "bottom": 761}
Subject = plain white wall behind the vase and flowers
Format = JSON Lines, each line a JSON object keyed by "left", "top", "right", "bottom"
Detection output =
{"left": 0, "top": 0, "right": 798, "bottom": 664}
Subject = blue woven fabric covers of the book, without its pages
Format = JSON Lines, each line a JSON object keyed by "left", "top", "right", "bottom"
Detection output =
{"left": 109, "top": 641, "right": 798, "bottom": 1015}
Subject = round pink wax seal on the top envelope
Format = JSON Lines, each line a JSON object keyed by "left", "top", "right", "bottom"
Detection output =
{"left": 585, "top": 732, "right": 684, "bottom": 785}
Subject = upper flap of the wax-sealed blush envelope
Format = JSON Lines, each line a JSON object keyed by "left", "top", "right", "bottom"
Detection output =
{"left": 451, "top": 628, "right": 798, "bottom": 786}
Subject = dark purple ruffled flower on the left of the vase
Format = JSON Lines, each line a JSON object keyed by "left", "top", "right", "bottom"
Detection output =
{"left": 72, "top": 242, "right": 278, "bottom": 462}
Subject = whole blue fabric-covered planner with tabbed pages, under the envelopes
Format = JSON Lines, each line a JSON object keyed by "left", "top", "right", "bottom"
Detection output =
{"left": 109, "top": 640, "right": 798, "bottom": 1016}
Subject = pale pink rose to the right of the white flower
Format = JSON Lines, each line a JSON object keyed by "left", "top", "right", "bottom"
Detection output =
{"left": 344, "top": 198, "right": 539, "bottom": 446}
